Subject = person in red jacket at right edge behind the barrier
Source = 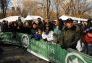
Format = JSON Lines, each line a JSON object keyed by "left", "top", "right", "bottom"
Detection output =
{"left": 83, "top": 27, "right": 92, "bottom": 56}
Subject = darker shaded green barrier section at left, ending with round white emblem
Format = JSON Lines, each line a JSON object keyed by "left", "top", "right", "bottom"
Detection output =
{"left": 0, "top": 32, "right": 30, "bottom": 46}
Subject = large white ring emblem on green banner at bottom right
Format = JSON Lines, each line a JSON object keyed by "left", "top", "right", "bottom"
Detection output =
{"left": 65, "top": 52, "right": 87, "bottom": 63}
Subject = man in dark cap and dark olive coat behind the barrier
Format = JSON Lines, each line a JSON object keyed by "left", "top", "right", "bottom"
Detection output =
{"left": 61, "top": 18, "right": 80, "bottom": 49}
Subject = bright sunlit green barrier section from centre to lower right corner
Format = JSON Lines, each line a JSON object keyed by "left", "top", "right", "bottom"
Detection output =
{"left": 28, "top": 39, "right": 92, "bottom": 63}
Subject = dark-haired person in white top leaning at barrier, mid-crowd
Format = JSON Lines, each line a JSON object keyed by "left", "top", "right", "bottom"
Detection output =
{"left": 42, "top": 26, "right": 54, "bottom": 42}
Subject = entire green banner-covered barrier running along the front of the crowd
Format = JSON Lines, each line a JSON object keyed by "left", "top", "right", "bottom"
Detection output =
{"left": 0, "top": 32, "right": 92, "bottom": 63}
